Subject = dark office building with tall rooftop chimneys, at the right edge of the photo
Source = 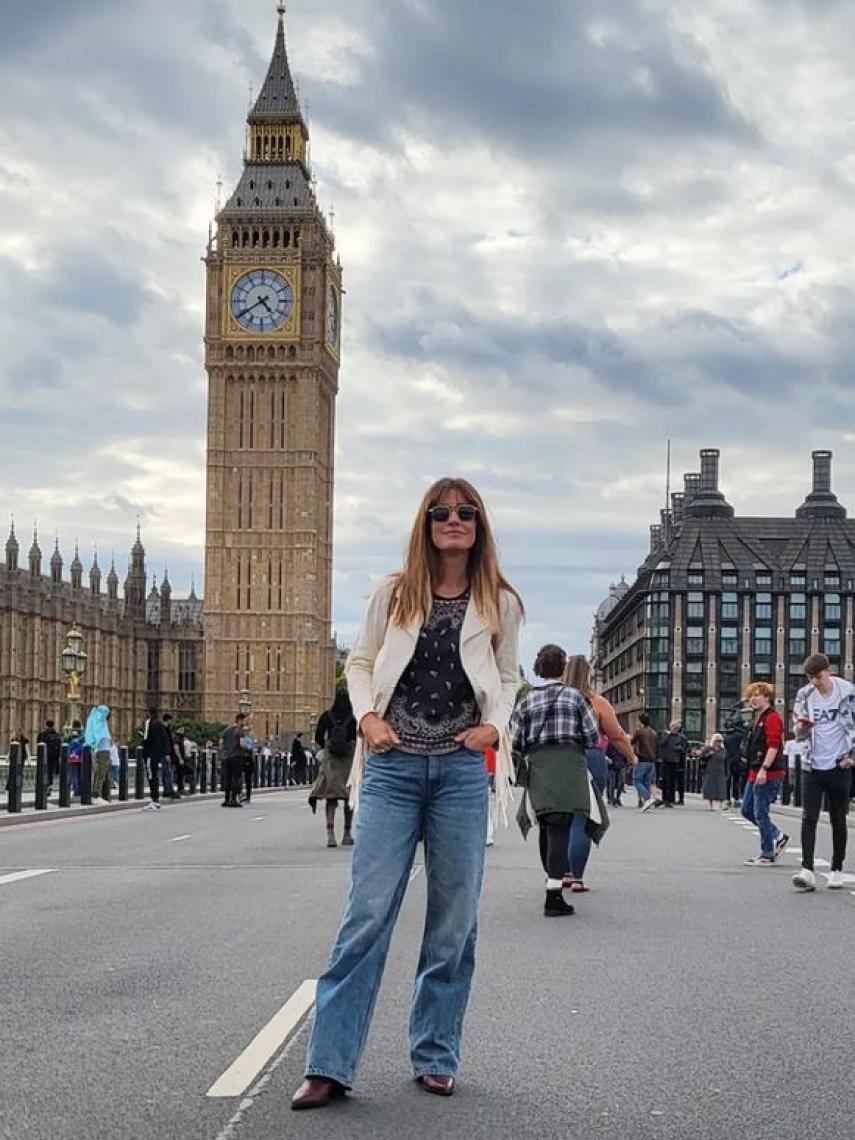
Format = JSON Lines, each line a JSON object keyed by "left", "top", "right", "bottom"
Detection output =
{"left": 593, "top": 449, "right": 855, "bottom": 740}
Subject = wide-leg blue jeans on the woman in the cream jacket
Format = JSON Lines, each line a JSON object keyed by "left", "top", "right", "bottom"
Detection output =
{"left": 306, "top": 749, "right": 488, "bottom": 1088}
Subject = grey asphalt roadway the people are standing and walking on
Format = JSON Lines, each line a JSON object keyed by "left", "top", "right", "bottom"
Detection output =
{"left": 0, "top": 792, "right": 855, "bottom": 1140}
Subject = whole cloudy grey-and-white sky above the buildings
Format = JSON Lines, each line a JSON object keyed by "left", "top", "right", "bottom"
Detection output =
{"left": 0, "top": 0, "right": 855, "bottom": 658}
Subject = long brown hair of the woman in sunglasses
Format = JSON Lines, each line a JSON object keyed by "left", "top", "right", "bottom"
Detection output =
{"left": 389, "top": 478, "right": 523, "bottom": 634}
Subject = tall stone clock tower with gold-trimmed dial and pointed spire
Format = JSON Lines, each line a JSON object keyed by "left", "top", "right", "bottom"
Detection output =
{"left": 205, "top": 2, "right": 342, "bottom": 738}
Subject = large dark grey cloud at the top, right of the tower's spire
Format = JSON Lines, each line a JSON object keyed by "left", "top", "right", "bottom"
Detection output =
{"left": 305, "top": 0, "right": 756, "bottom": 162}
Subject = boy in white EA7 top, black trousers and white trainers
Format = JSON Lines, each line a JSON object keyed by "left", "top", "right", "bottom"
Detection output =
{"left": 792, "top": 653, "right": 855, "bottom": 890}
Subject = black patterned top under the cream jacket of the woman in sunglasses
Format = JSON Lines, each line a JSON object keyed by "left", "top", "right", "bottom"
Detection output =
{"left": 386, "top": 591, "right": 481, "bottom": 756}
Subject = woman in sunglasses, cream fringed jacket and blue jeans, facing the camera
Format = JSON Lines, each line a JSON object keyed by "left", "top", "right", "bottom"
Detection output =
{"left": 292, "top": 479, "right": 522, "bottom": 1108}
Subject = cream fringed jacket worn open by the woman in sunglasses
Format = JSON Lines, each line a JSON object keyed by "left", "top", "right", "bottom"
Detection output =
{"left": 344, "top": 578, "right": 522, "bottom": 822}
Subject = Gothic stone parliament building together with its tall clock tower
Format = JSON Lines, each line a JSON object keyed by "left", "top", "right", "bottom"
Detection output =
{"left": 0, "top": 3, "right": 342, "bottom": 750}
